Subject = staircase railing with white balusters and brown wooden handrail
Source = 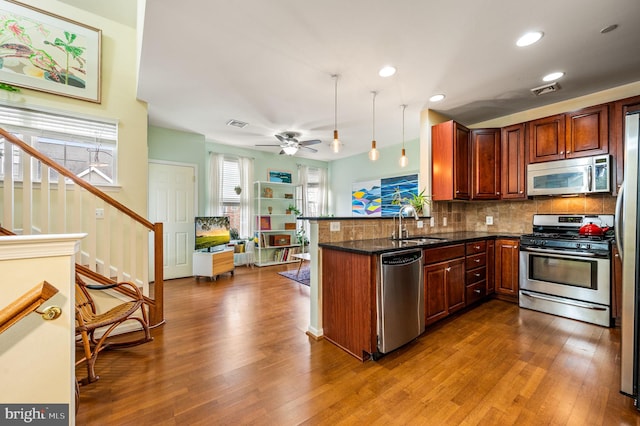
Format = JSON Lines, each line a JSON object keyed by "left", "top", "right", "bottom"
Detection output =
{"left": 0, "top": 128, "right": 164, "bottom": 325}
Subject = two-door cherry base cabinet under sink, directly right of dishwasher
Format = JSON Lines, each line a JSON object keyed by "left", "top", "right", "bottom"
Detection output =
{"left": 424, "top": 244, "right": 465, "bottom": 325}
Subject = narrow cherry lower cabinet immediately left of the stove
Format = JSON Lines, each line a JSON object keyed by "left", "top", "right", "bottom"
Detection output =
{"left": 495, "top": 239, "right": 520, "bottom": 302}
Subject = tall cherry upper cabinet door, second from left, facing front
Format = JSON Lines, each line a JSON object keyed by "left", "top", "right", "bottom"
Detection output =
{"left": 471, "top": 129, "right": 500, "bottom": 200}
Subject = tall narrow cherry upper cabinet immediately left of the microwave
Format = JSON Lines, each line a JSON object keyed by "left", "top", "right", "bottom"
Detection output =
{"left": 500, "top": 123, "right": 527, "bottom": 200}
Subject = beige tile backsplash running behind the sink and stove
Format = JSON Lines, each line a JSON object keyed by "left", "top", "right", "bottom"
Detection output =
{"left": 318, "top": 194, "right": 616, "bottom": 242}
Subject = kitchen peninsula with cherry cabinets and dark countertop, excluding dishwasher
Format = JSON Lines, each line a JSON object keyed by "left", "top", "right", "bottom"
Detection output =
{"left": 305, "top": 213, "right": 520, "bottom": 360}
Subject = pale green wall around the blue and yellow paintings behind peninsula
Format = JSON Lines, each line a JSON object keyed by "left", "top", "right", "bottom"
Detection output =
{"left": 329, "top": 139, "right": 420, "bottom": 217}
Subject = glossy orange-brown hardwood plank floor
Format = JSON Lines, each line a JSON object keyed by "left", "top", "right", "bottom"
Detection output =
{"left": 77, "top": 266, "right": 640, "bottom": 425}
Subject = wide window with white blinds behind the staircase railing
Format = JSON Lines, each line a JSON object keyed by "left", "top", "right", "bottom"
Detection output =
{"left": 0, "top": 105, "right": 117, "bottom": 185}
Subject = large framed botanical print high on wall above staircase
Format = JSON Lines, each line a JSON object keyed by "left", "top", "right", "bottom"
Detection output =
{"left": 0, "top": 0, "right": 102, "bottom": 103}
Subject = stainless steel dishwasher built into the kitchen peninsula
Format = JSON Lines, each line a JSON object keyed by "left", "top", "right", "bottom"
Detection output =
{"left": 372, "top": 249, "right": 425, "bottom": 360}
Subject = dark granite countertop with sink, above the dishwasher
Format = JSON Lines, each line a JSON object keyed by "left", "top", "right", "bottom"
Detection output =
{"left": 318, "top": 231, "right": 520, "bottom": 254}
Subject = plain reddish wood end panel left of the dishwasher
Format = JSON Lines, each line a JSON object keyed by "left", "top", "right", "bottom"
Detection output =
{"left": 322, "top": 248, "right": 377, "bottom": 360}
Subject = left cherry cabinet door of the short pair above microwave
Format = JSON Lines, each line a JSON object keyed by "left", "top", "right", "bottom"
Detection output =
{"left": 527, "top": 114, "right": 565, "bottom": 163}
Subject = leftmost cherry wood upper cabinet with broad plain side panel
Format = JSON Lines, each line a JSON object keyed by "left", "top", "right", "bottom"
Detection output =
{"left": 431, "top": 120, "right": 471, "bottom": 201}
